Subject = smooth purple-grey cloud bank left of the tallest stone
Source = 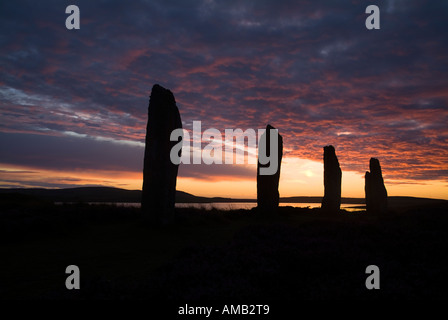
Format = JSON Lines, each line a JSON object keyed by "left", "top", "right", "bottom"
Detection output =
{"left": 0, "top": 133, "right": 144, "bottom": 171}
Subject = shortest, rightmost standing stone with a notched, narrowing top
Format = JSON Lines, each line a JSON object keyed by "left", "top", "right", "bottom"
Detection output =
{"left": 365, "top": 158, "right": 387, "bottom": 215}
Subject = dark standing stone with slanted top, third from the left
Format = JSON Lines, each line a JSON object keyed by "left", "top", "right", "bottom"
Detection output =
{"left": 322, "top": 146, "right": 342, "bottom": 211}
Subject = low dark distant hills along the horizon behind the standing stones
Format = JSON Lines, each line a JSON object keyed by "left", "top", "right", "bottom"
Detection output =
{"left": 0, "top": 187, "right": 448, "bottom": 207}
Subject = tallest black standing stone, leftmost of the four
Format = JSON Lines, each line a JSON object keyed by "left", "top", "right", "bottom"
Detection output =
{"left": 142, "top": 84, "right": 182, "bottom": 224}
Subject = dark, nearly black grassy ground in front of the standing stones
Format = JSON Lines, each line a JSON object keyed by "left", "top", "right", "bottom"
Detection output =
{"left": 0, "top": 197, "right": 448, "bottom": 301}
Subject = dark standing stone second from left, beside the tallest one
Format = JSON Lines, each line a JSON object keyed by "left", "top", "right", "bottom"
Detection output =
{"left": 257, "top": 124, "right": 283, "bottom": 212}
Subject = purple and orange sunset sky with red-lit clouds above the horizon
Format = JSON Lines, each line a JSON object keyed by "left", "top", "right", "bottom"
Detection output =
{"left": 0, "top": 0, "right": 448, "bottom": 199}
